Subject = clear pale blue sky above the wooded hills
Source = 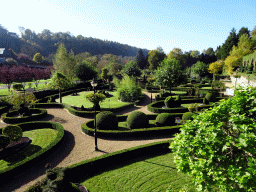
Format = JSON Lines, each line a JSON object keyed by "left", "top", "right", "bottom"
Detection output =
{"left": 0, "top": 0, "right": 256, "bottom": 54}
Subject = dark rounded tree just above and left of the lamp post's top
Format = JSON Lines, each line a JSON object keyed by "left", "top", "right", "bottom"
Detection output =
{"left": 74, "top": 61, "right": 98, "bottom": 82}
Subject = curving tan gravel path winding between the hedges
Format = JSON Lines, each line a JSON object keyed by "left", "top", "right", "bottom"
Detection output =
{"left": 0, "top": 92, "right": 174, "bottom": 192}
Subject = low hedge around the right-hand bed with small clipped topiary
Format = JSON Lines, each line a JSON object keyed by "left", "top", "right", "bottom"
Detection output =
{"left": 147, "top": 99, "right": 215, "bottom": 113}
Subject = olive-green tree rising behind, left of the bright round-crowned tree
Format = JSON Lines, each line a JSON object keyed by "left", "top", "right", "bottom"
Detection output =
{"left": 148, "top": 47, "right": 166, "bottom": 70}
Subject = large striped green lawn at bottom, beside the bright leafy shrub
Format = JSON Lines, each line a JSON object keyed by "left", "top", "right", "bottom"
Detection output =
{"left": 80, "top": 153, "right": 220, "bottom": 192}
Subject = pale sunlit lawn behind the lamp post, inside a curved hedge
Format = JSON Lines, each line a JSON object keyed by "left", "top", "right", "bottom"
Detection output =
{"left": 56, "top": 91, "right": 133, "bottom": 108}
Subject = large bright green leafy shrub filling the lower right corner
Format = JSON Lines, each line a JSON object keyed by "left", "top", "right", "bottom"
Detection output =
{"left": 170, "top": 86, "right": 256, "bottom": 192}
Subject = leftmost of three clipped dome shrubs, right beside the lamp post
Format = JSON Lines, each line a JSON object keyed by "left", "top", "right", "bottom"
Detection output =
{"left": 96, "top": 111, "right": 118, "bottom": 130}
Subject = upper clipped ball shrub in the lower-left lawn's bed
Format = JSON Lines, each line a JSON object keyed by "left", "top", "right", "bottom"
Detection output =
{"left": 3, "top": 125, "right": 22, "bottom": 142}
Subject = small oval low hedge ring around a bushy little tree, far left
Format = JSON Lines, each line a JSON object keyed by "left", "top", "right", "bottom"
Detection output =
{"left": 1, "top": 108, "right": 47, "bottom": 124}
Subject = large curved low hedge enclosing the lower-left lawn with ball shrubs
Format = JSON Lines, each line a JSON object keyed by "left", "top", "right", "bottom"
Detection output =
{"left": 0, "top": 121, "right": 64, "bottom": 183}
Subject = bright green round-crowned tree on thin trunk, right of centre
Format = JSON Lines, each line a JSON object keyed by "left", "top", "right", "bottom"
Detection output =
{"left": 154, "top": 57, "right": 187, "bottom": 93}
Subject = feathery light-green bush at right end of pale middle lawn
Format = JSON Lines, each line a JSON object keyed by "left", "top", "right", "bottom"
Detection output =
{"left": 114, "top": 75, "right": 142, "bottom": 102}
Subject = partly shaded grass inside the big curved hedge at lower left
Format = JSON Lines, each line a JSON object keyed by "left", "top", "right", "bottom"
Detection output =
{"left": 0, "top": 128, "right": 58, "bottom": 170}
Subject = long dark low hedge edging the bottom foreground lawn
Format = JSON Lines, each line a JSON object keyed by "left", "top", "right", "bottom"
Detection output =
{"left": 65, "top": 140, "right": 171, "bottom": 183}
